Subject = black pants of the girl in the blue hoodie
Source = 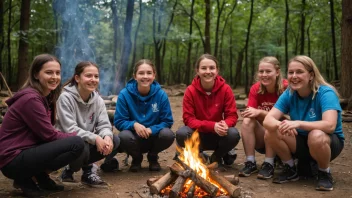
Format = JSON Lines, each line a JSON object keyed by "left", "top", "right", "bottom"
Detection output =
{"left": 119, "top": 128, "right": 175, "bottom": 163}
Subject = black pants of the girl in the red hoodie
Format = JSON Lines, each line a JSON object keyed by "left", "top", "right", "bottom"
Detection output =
{"left": 176, "top": 126, "right": 241, "bottom": 160}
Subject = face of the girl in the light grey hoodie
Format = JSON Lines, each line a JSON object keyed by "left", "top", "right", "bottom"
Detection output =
{"left": 75, "top": 65, "right": 99, "bottom": 94}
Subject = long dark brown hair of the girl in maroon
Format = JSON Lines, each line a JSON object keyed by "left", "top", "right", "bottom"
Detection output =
{"left": 21, "top": 54, "right": 61, "bottom": 124}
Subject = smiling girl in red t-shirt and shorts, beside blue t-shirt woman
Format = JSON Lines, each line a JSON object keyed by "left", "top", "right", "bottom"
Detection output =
{"left": 239, "top": 56, "right": 288, "bottom": 179}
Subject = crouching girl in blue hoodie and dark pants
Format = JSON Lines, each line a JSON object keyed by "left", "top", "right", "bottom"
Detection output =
{"left": 114, "top": 59, "right": 174, "bottom": 172}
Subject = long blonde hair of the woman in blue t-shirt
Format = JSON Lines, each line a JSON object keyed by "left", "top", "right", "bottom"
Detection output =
{"left": 288, "top": 55, "right": 340, "bottom": 99}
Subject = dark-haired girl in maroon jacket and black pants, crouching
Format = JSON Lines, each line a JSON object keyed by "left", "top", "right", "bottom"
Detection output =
{"left": 0, "top": 54, "right": 84, "bottom": 197}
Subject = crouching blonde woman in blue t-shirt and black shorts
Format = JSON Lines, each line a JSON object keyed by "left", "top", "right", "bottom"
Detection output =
{"left": 264, "top": 56, "right": 345, "bottom": 190}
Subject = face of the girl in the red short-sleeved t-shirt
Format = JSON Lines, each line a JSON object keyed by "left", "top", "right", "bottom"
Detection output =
{"left": 258, "top": 62, "right": 280, "bottom": 87}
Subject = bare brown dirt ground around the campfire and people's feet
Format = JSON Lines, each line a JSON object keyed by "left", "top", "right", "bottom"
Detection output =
{"left": 0, "top": 89, "right": 352, "bottom": 198}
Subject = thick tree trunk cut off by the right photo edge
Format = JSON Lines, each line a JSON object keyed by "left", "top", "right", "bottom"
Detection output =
{"left": 341, "top": 0, "right": 352, "bottom": 110}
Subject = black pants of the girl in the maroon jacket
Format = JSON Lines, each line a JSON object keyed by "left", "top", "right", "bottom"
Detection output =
{"left": 1, "top": 136, "right": 84, "bottom": 181}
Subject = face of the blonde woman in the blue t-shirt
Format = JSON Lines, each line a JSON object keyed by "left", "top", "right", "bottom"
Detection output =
{"left": 287, "top": 61, "right": 314, "bottom": 91}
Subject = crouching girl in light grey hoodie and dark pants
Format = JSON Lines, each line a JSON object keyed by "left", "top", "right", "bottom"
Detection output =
{"left": 56, "top": 61, "right": 120, "bottom": 187}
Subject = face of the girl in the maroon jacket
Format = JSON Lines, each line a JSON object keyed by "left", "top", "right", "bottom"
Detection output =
{"left": 34, "top": 61, "right": 61, "bottom": 96}
